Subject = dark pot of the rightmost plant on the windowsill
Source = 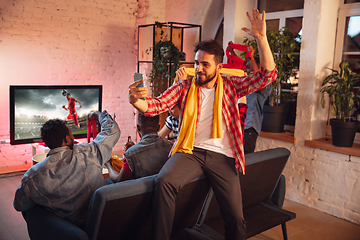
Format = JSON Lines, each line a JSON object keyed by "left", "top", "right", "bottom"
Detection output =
{"left": 330, "top": 118, "right": 360, "bottom": 147}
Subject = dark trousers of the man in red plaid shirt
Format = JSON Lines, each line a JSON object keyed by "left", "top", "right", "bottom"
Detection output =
{"left": 152, "top": 148, "right": 246, "bottom": 240}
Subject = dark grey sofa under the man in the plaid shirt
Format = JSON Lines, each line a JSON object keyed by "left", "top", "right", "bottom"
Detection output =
{"left": 23, "top": 148, "right": 296, "bottom": 240}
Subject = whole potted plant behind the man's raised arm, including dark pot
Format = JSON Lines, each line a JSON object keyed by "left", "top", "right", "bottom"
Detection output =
{"left": 244, "top": 27, "right": 300, "bottom": 132}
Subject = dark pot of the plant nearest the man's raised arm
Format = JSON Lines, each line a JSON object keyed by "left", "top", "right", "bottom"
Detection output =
{"left": 261, "top": 104, "right": 289, "bottom": 133}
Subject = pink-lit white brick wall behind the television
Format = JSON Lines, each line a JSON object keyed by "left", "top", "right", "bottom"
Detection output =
{"left": 0, "top": 0, "right": 153, "bottom": 167}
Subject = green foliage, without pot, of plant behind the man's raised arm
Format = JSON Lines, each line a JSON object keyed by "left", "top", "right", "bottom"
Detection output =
{"left": 244, "top": 27, "right": 301, "bottom": 106}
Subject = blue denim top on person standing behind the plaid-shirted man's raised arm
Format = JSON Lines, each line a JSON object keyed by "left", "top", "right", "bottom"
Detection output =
{"left": 245, "top": 84, "right": 272, "bottom": 134}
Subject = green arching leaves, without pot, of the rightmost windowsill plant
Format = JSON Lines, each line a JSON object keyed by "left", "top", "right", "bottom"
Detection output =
{"left": 321, "top": 61, "right": 360, "bottom": 122}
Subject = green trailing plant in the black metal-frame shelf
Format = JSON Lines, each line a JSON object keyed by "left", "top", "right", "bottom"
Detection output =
{"left": 147, "top": 22, "right": 185, "bottom": 96}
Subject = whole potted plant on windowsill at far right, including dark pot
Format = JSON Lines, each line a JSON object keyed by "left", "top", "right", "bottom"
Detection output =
{"left": 321, "top": 61, "right": 360, "bottom": 147}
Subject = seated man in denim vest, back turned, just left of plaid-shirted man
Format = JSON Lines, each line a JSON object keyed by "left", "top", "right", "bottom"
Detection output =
{"left": 106, "top": 113, "right": 172, "bottom": 183}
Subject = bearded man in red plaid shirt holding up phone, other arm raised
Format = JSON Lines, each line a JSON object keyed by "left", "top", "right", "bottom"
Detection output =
{"left": 129, "top": 10, "right": 277, "bottom": 240}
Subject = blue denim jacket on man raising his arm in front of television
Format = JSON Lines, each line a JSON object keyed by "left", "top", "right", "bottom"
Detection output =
{"left": 14, "top": 111, "right": 120, "bottom": 225}
